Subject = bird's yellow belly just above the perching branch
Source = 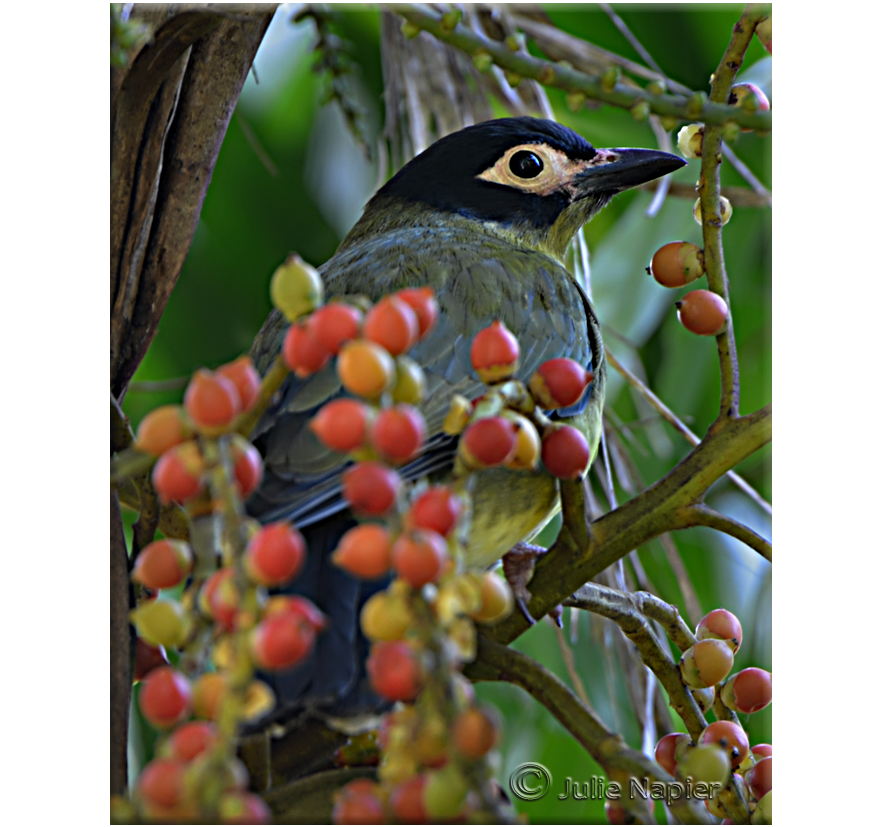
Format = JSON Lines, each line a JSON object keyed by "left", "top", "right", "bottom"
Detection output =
{"left": 466, "top": 468, "right": 559, "bottom": 568}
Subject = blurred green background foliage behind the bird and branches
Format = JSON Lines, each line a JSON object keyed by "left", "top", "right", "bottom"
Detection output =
{"left": 125, "top": 4, "right": 772, "bottom": 823}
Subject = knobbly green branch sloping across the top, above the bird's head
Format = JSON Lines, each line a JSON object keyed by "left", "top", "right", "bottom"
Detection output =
{"left": 385, "top": 3, "right": 773, "bottom": 130}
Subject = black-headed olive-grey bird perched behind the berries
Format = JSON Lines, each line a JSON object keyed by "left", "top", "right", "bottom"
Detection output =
{"left": 247, "top": 117, "right": 685, "bottom": 718}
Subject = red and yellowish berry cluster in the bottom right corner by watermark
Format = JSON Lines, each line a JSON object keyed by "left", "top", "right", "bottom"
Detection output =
{"left": 654, "top": 609, "right": 773, "bottom": 824}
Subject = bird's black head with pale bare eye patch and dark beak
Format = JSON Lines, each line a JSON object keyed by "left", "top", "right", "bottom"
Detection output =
{"left": 354, "top": 117, "right": 684, "bottom": 256}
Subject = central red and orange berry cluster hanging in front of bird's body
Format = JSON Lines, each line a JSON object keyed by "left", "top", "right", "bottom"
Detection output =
{"left": 273, "top": 261, "right": 592, "bottom": 823}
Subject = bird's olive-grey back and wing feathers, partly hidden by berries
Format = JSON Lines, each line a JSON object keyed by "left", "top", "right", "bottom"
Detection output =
{"left": 249, "top": 227, "right": 593, "bottom": 526}
